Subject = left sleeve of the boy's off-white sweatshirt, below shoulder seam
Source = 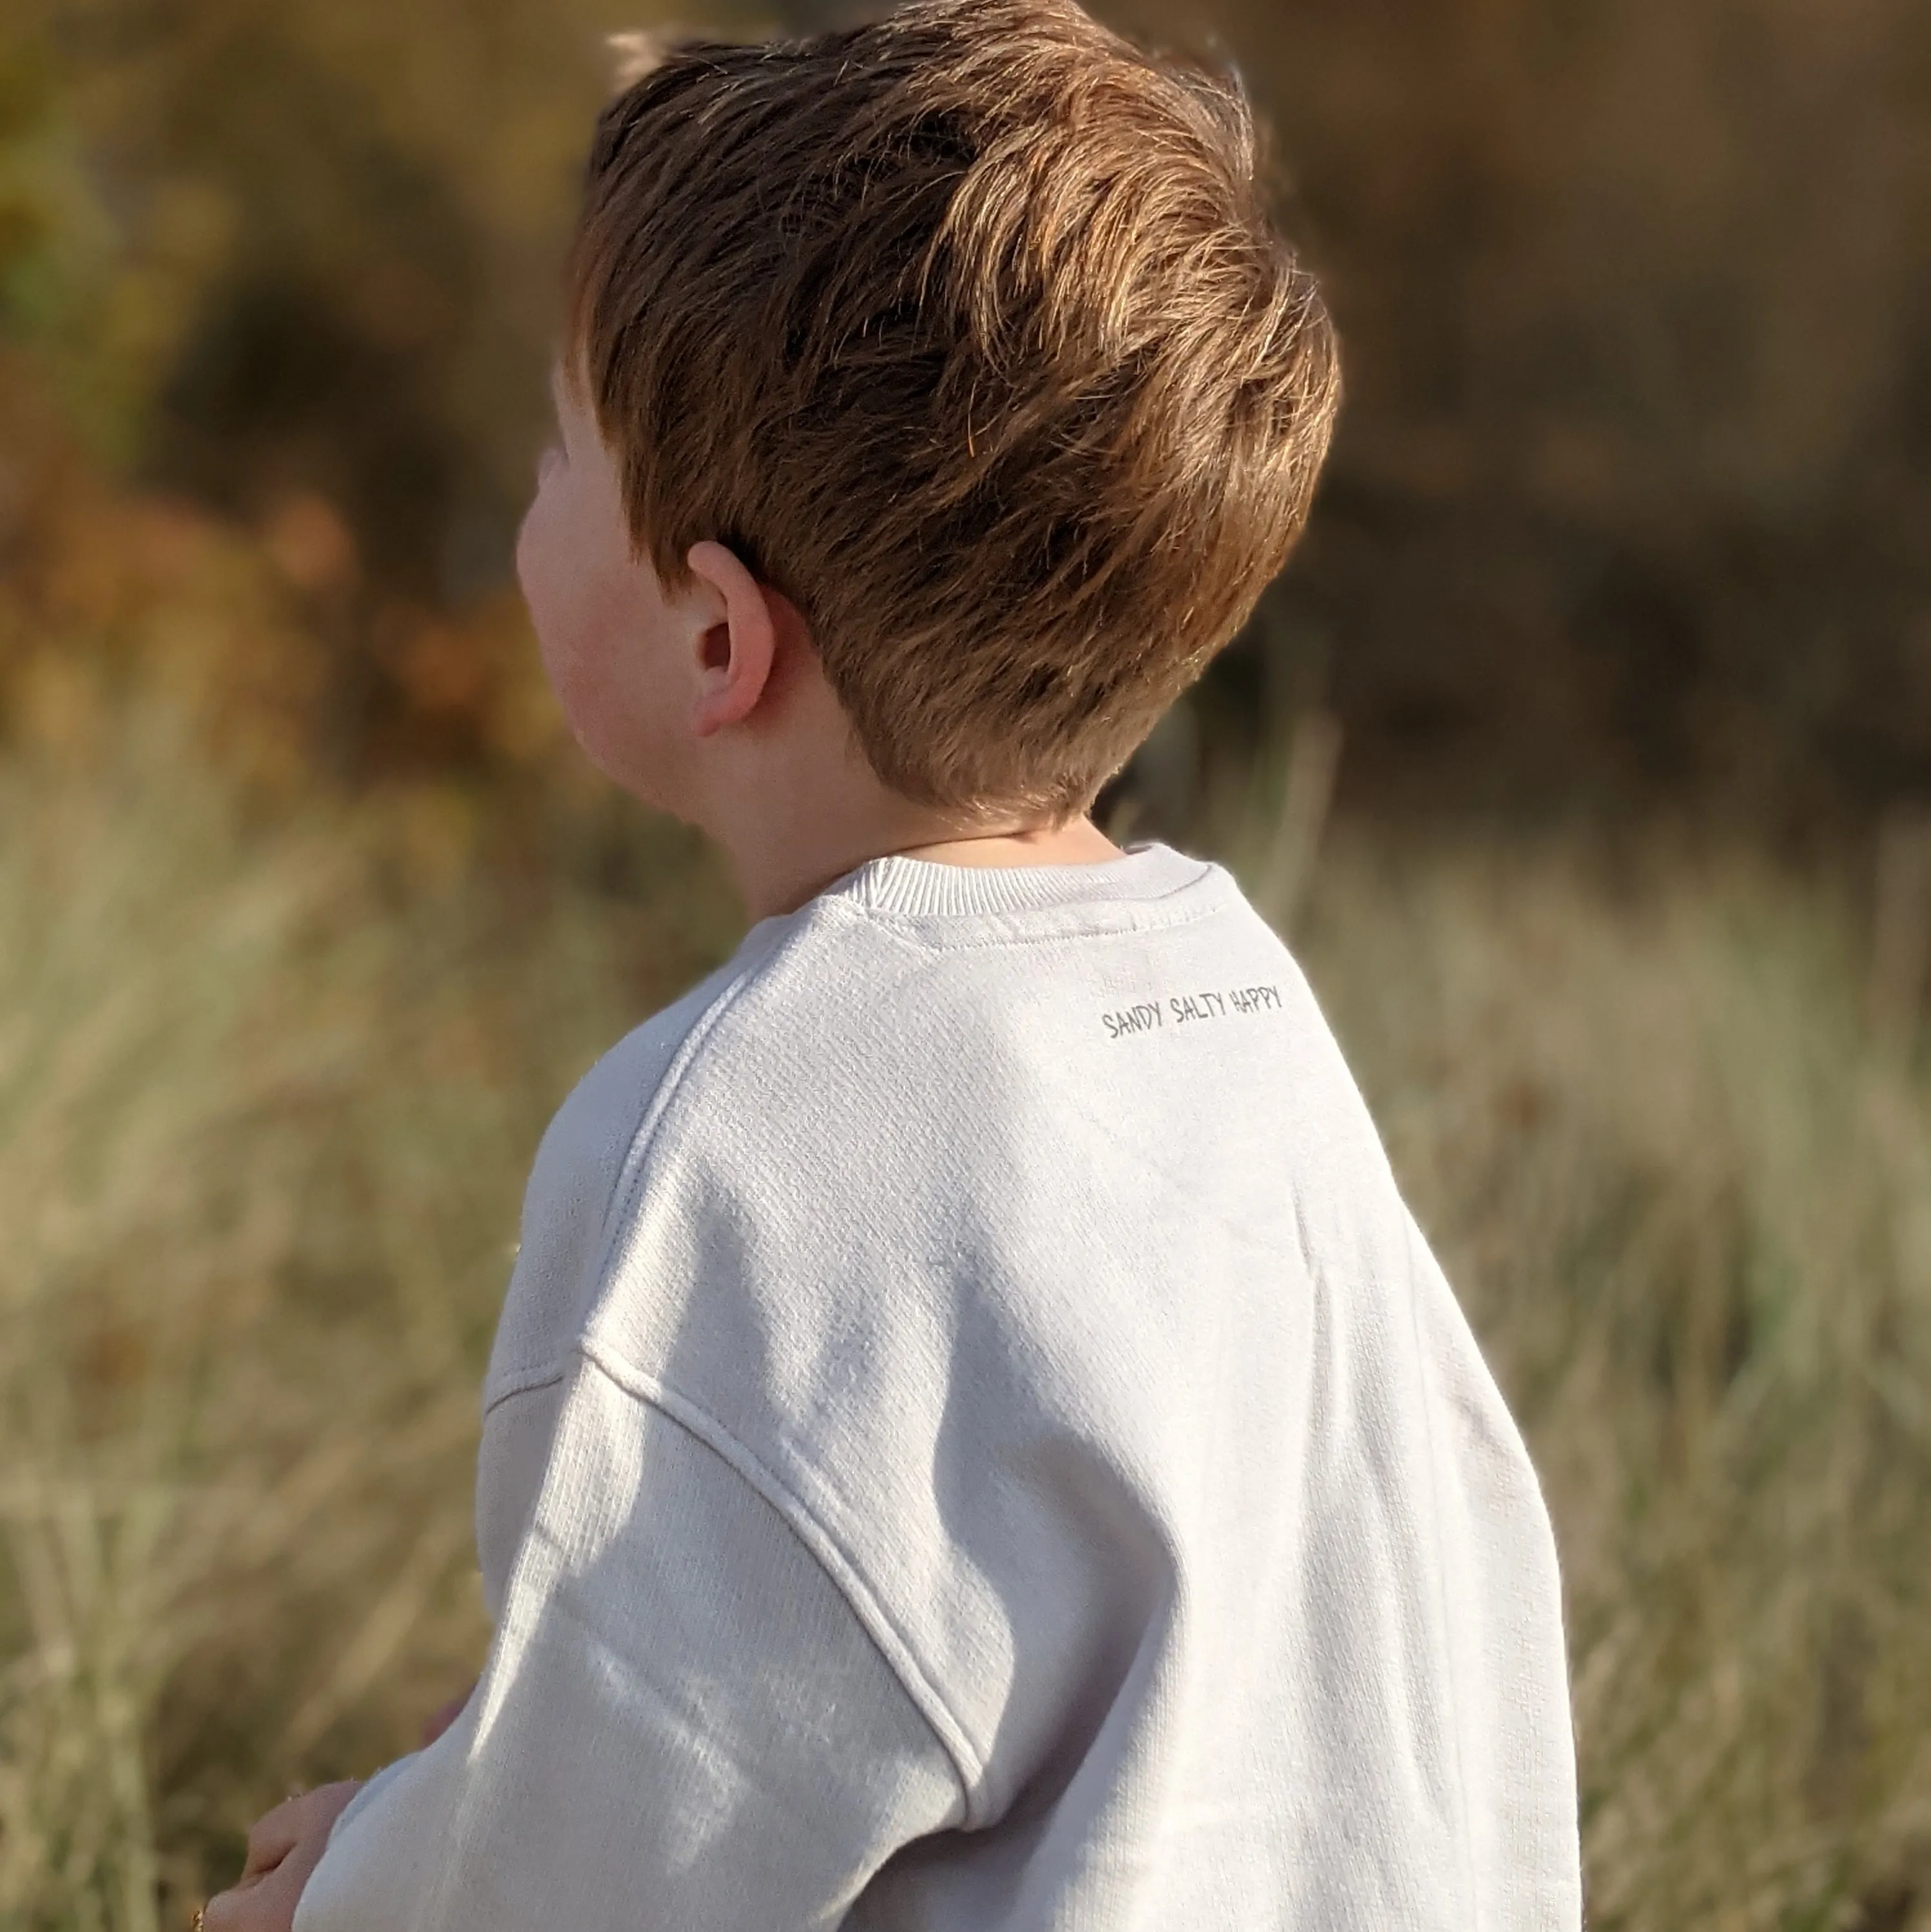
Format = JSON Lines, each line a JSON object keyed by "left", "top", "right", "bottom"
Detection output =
{"left": 296, "top": 1360, "right": 964, "bottom": 1932}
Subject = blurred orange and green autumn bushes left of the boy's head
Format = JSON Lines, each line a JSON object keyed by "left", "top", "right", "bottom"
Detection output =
{"left": 0, "top": 0, "right": 695, "bottom": 782}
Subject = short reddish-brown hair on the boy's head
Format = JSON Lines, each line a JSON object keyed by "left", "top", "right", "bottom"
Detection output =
{"left": 570, "top": 0, "right": 1338, "bottom": 817}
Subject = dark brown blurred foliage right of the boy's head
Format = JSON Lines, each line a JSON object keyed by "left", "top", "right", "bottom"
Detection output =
{"left": 1189, "top": 0, "right": 1931, "bottom": 813}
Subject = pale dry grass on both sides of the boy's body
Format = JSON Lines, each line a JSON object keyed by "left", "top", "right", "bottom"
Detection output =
{"left": 0, "top": 726, "right": 1931, "bottom": 1932}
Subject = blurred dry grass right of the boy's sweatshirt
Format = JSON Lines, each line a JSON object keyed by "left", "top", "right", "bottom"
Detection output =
{"left": 1307, "top": 848, "right": 1931, "bottom": 1932}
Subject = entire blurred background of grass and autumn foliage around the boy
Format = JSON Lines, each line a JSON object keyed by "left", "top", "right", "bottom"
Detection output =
{"left": 0, "top": 0, "right": 1931, "bottom": 1932}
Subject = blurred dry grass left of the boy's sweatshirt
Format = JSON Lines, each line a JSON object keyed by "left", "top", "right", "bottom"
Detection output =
{"left": 0, "top": 719, "right": 720, "bottom": 1932}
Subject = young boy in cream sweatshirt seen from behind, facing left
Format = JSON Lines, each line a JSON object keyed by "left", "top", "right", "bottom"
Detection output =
{"left": 207, "top": 0, "right": 1580, "bottom": 1932}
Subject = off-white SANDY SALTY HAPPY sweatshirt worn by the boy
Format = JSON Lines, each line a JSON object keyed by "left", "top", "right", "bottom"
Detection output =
{"left": 296, "top": 844, "right": 1582, "bottom": 1932}
